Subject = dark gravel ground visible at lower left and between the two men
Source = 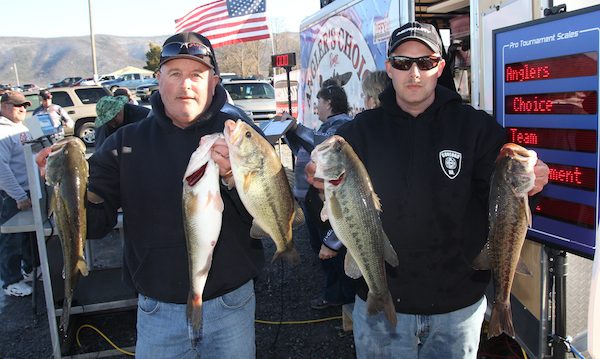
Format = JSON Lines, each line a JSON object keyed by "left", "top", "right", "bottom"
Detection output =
{"left": 0, "top": 226, "right": 354, "bottom": 359}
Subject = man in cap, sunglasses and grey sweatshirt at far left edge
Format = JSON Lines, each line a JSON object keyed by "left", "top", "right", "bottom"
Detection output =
{"left": 0, "top": 91, "right": 33, "bottom": 297}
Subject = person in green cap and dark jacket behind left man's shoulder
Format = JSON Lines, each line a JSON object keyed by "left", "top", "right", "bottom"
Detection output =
{"left": 94, "top": 96, "right": 150, "bottom": 148}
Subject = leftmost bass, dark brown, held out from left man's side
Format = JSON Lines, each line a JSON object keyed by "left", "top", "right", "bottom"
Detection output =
{"left": 46, "top": 137, "right": 89, "bottom": 333}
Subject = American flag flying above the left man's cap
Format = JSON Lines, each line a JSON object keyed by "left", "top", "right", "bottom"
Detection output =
{"left": 175, "top": 0, "right": 270, "bottom": 48}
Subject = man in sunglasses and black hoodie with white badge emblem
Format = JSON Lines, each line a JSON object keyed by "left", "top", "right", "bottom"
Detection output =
{"left": 306, "top": 22, "right": 549, "bottom": 359}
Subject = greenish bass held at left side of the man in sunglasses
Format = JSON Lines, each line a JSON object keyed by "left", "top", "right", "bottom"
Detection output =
{"left": 311, "top": 135, "right": 398, "bottom": 327}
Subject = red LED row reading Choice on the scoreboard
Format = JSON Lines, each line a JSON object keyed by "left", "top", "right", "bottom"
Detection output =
{"left": 504, "top": 91, "right": 598, "bottom": 115}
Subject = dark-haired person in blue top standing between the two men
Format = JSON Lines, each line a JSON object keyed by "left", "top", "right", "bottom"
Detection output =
{"left": 286, "top": 79, "right": 355, "bottom": 310}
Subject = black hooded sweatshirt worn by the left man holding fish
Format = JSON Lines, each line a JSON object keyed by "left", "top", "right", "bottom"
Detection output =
{"left": 87, "top": 86, "right": 264, "bottom": 303}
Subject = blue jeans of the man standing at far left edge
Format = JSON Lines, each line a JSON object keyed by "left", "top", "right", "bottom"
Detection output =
{"left": 0, "top": 191, "right": 33, "bottom": 288}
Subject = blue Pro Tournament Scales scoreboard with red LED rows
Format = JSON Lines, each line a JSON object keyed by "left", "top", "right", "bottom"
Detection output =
{"left": 493, "top": 6, "right": 600, "bottom": 257}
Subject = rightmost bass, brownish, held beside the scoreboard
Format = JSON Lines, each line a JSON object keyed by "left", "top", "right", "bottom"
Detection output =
{"left": 488, "top": 143, "right": 537, "bottom": 338}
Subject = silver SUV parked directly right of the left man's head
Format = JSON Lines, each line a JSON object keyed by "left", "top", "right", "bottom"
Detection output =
{"left": 223, "top": 80, "right": 276, "bottom": 125}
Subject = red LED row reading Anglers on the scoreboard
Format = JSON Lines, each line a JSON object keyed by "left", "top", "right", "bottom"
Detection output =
{"left": 504, "top": 52, "right": 598, "bottom": 82}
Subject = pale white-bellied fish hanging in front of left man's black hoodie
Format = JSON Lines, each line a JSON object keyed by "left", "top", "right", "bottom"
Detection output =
{"left": 183, "top": 133, "right": 224, "bottom": 330}
